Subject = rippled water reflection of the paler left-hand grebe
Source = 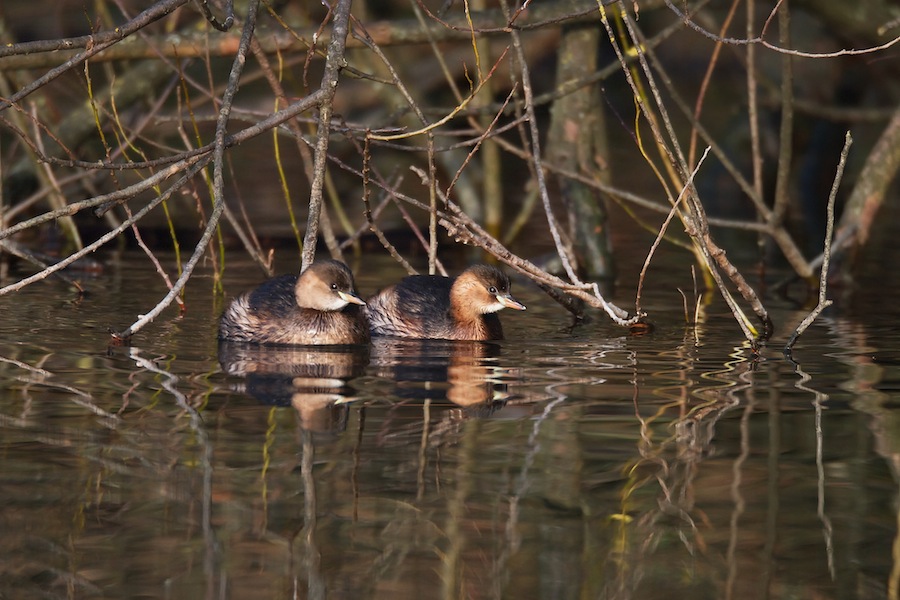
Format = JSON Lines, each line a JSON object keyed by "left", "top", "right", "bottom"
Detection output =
{"left": 219, "top": 341, "right": 369, "bottom": 433}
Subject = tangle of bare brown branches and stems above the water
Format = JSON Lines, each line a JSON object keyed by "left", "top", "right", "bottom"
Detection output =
{"left": 0, "top": 0, "right": 900, "bottom": 338}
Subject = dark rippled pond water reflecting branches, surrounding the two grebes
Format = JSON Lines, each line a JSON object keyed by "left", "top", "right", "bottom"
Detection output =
{"left": 0, "top": 250, "right": 900, "bottom": 599}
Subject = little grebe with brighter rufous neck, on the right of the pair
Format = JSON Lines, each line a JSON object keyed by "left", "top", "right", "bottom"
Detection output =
{"left": 366, "top": 265, "right": 525, "bottom": 340}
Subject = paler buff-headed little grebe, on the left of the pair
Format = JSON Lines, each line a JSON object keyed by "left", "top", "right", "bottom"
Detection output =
{"left": 219, "top": 260, "right": 369, "bottom": 345}
